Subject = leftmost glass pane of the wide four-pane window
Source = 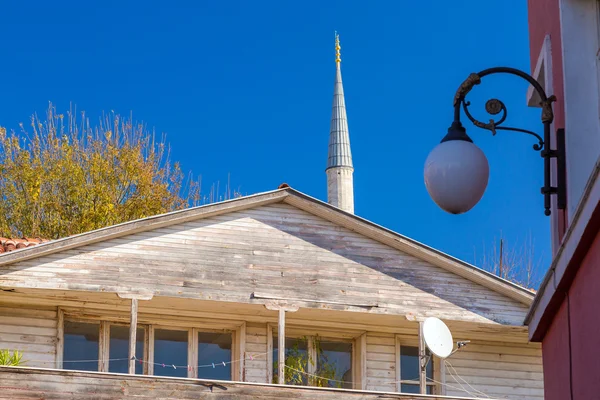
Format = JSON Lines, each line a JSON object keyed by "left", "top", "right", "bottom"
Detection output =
{"left": 63, "top": 321, "right": 100, "bottom": 371}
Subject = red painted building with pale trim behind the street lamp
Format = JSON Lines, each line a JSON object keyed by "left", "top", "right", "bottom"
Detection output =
{"left": 526, "top": 0, "right": 600, "bottom": 400}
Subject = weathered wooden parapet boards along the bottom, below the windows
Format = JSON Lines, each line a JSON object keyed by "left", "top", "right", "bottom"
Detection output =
{"left": 0, "top": 367, "right": 480, "bottom": 400}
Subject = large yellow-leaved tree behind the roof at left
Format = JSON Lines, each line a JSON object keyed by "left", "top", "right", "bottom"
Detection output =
{"left": 0, "top": 104, "right": 237, "bottom": 239}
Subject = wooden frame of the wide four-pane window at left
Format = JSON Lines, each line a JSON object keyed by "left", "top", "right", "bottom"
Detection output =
{"left": 56, "top": 307, "right": 246, "bottom": 382}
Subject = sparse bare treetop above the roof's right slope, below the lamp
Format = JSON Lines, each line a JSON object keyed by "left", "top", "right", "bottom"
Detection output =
{"left": 480, "top": 234, "right": 541, "bottom": 289}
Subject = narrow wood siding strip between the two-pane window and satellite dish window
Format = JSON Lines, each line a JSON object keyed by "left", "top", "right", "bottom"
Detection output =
{"left": 367, "top": 332, "right": 396, "bottom": 392}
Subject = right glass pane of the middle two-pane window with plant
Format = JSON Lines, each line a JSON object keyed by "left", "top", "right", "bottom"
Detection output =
{"left": 316, "top": 341, "right": 352, "bottom": 389}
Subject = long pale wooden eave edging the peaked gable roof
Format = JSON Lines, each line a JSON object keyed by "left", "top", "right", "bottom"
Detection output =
{"left": 0, "top": 187, "right": 534, "bottom": 306}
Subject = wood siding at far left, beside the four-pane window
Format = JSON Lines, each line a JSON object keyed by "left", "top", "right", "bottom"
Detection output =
{"left": 0, "top": 303, "right": 57, "bottom": 368}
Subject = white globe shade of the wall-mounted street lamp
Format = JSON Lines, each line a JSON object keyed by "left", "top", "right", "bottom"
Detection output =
{"left": 424, "top": 140, "right": 490, "bottom": 214}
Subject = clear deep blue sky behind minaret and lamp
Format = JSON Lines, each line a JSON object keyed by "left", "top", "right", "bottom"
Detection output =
{"left": 0, "top": 0, "right": 550, "bottom": 284}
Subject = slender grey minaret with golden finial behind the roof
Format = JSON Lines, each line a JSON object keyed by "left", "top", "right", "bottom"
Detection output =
{"left": 325, "top": 34, "right": 354, "bottom": 214}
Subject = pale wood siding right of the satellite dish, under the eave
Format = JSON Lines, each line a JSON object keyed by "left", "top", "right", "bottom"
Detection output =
{"left": 446, "top": 343, "right": 544, "bottom": 400}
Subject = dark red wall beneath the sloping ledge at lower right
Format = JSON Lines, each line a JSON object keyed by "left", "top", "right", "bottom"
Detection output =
{"left": 542, "top": 230, "right": 600, "bottom": 400}
